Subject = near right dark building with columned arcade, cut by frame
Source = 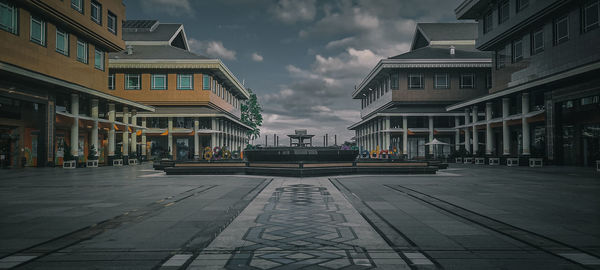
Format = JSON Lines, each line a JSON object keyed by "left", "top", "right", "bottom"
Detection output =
{"left": 447, "top": 0, "right": 600, "bottom": 166}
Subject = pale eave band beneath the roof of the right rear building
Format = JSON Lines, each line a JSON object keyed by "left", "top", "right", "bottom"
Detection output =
{"left": 352, "top": 58, "right": 492, "bottom": 99}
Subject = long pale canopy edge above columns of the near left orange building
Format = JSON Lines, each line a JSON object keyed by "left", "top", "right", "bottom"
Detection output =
{"left": 0, "top": 63, "right": 155, "bottom": 112}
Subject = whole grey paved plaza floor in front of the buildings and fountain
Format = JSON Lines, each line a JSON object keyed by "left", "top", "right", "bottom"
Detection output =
{"left": 0, "top": 165, "right": 600, "bottom": 269}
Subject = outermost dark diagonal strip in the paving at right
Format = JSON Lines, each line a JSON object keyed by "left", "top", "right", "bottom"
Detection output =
{"left": 384, "top": 184, "right": 600, "bottom": 269}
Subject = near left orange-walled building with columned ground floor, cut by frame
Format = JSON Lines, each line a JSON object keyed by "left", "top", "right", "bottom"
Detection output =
{"left": 0, "top": 0, "right": 154, "bottom": 167}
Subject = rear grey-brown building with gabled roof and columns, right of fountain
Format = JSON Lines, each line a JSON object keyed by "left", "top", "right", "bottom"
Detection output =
{"left": 349, "top": 23, "right": 492, "bottom": 159}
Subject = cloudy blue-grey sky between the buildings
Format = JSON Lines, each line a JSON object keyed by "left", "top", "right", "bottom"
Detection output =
{"left": 125, "top": 0, "right": 461, "bottom": 145}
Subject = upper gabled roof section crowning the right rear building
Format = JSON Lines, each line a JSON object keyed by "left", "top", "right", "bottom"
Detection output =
{"left": 417, "top": 23, "right": 477, "bottom": 41}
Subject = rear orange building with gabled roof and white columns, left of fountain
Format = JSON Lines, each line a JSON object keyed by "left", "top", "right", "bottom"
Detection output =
{"left": 106, "top": 20, "right": 249, "bottom": 160}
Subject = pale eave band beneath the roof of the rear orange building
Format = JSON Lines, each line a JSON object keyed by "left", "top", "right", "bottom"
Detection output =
{"left": 108, "top": 59, "right": 250, "bottom": 99}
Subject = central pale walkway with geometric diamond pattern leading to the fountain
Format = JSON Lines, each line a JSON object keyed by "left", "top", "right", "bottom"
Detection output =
{"left": 188, "top": 178, "right": 409, "bottom": 269}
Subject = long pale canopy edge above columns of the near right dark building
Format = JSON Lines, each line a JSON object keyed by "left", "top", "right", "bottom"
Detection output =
{"left": 446, "top": 62, "right": 600, "bottom": 111}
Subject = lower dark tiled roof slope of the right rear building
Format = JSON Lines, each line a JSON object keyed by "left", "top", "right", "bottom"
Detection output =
{"left": 389, "top": 46, "right": 492, "bottom": 59}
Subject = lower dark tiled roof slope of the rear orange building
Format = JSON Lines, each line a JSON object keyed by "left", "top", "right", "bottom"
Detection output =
{"left": 108, "top": 45, "right": 211, "bottom": 59}
